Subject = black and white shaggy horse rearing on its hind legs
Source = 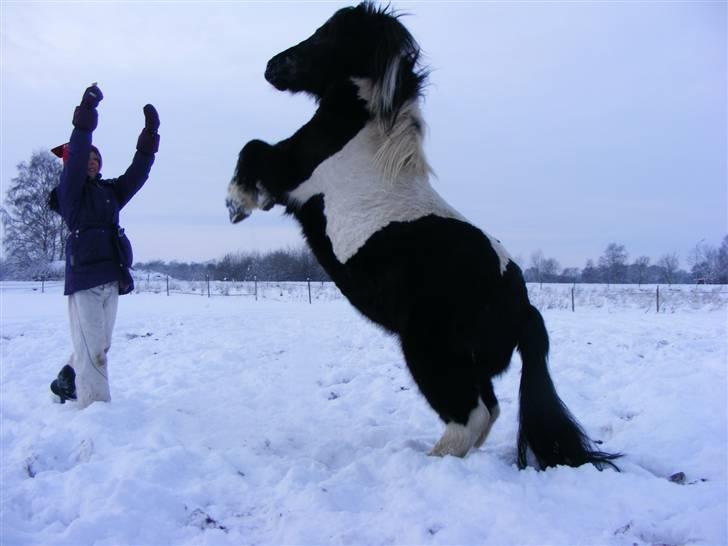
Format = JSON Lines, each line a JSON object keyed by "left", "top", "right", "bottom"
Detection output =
{"left": 227, "top": 3, "right": 616, "bottom": 468}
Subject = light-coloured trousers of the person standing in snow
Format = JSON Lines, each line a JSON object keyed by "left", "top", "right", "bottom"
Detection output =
{"left": 68, "top": 282, "right": 119, "bottom": 408}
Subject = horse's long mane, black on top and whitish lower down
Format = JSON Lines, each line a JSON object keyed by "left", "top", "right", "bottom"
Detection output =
{"left": 356, "top": 2, "right": 432, "bottom": 181}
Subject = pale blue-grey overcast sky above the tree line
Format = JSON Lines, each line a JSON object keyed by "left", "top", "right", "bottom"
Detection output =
{"left": 0, "top": 0, "right": 728, "bottom": 267}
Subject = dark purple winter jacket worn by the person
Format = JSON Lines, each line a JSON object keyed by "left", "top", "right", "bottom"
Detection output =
{"left": 57, "top": 129, "right": 154, "bottom": 295}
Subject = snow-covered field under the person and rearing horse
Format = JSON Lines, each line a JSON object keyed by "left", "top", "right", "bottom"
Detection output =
{"left": 0, "top": 283, "right": 728, "bottom": 546}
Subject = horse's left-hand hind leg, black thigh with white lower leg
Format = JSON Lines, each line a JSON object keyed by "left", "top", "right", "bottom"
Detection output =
{"left": 402, "top": 336, "right": 490, "bottom": 457}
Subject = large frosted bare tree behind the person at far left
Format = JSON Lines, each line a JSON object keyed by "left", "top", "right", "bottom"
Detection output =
{"left": 0, "top": 151, "right": 68, "bottom": 272}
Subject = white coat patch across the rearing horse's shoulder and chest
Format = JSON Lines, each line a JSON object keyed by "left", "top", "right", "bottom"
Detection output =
{"left": 290, "top": 127, "right": 463, "bottom": 263}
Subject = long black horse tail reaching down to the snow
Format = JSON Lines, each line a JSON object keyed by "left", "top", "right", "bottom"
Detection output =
{"left": 518, "top": 305, "right": 620, "bottom": 470}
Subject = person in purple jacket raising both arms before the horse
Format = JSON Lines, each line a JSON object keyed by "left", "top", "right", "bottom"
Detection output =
{"left": 50, "top": 83, "right": 159, "bottom": 408}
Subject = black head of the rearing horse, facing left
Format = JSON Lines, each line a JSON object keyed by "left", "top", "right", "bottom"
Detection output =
{"left": 265, "top": 2, "right": 425, "bottom": 125}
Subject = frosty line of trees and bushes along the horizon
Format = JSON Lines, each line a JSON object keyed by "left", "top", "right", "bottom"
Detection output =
{"left": 0, "top": 151, "right": 728, "bottom": 284}
